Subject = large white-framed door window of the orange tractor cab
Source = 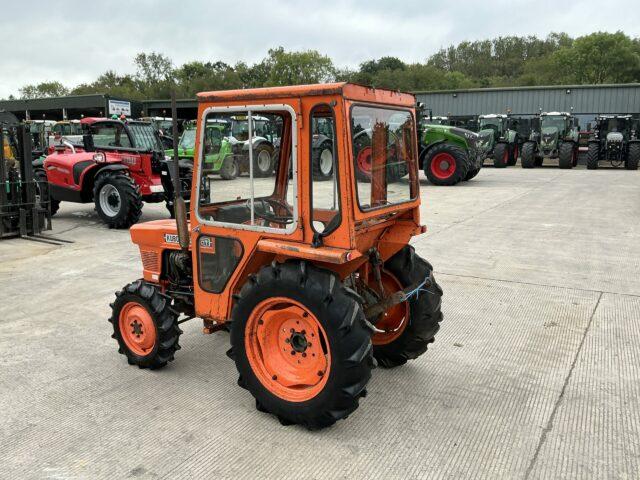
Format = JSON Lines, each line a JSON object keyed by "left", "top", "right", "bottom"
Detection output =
{"left": 198, "top": 107, "right": 297, "bottom": 231}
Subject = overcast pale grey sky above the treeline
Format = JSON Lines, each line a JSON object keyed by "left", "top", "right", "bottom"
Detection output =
{"left": 0, "top": 0, "right": 640, "bottom": 98}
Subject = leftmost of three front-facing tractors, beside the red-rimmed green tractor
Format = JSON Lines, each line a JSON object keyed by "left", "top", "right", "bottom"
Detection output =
{"left": 478, "top": 113, "right": 520, "bottom": 168}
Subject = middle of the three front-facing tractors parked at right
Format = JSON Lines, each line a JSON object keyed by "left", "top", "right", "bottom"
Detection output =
{"left": 522, "top": 112, "right": 580, "bottom": 168}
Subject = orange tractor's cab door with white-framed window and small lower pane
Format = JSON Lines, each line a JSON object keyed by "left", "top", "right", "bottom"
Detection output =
{"left": 191, "top": 104, "right": 302, "bottom": 322}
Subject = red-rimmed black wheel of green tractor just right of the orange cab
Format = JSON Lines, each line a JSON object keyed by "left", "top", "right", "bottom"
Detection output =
{"left": 423, "top": 143, "right": 470, "bottom": 185}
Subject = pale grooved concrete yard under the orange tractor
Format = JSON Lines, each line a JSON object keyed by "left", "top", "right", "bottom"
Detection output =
{"left": 0, "top": 164, "right": 640, "bottom": 479}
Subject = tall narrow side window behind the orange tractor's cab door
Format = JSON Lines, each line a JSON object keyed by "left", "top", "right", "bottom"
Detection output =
{"left": 310, "top": 105, "right": 342, "bottom": 235}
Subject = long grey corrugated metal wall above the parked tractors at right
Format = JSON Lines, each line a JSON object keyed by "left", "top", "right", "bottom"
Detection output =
{"left": 416, "top": 84, "right": 640, "bottom": 116}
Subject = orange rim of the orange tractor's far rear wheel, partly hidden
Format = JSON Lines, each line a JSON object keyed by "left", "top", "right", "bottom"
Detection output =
{"left": 367, "top": 270, "right": 409, "bottom": 345}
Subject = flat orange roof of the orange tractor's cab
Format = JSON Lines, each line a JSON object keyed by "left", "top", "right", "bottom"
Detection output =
{"left": 198, "top": 82, "right": 416, "bottom": 107}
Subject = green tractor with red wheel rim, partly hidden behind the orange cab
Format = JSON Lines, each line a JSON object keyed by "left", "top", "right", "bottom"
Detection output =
{"left": 418, "top": 117, "right": 484, "bottom": 185}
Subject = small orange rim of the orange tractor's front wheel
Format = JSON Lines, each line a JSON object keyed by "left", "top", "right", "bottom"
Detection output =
{"left": 118, "top": 302, "right": 157, "bottom": 356}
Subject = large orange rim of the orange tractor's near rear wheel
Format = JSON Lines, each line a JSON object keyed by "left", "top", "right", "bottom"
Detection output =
{"left": 245, "top": 297, "right": 331, "bottom": 402}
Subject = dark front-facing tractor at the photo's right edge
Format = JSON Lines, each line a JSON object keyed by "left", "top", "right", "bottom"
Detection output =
{"left": 587, "top": 115, "right": 640, "bottom": 170}
